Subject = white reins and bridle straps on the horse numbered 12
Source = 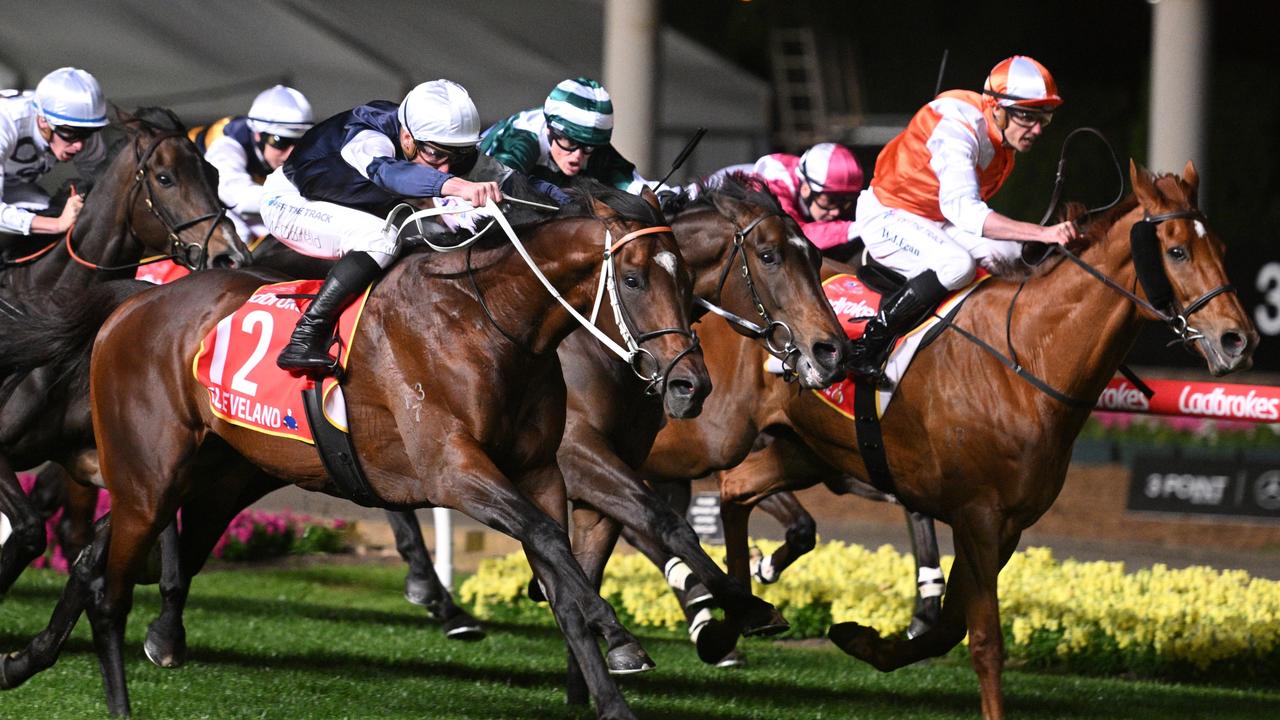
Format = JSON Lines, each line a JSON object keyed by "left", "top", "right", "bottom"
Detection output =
{"left": 387, "top": 200, "right": 699, "bottom": 395}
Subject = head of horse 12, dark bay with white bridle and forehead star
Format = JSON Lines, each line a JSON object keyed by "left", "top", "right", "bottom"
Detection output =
{"left": 577, "top": 184, "right": 712, "bottom": 418}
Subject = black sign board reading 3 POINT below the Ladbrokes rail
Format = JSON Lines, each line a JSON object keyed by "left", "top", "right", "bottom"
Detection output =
{"left": 1126, "top": 455, "right": 1280, "bottom": 521}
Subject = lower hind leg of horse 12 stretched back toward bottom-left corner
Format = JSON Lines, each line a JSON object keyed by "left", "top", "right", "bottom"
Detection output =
{"left": 0, "top": 515, "right": 111, "bottom": 689}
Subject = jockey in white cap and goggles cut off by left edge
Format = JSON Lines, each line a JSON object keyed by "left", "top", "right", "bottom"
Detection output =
{"left": 0, "top": 68, "right": 108, "bottom": 234}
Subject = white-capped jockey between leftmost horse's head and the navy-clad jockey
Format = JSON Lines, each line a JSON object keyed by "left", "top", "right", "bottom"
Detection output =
{"left": 188, "top": 85, "right": 314, "bottom": 243}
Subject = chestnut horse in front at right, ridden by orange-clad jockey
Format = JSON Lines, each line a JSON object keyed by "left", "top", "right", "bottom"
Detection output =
{"left": 634, "top": 163, "right": 1258, "bottom": 719}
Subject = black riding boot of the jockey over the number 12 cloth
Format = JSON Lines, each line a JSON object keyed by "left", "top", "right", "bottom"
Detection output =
{"left": 275, "top": 251, "right": 383, "bottom": 377}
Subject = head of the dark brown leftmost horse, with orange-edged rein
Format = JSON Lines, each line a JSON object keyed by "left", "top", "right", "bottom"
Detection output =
{"left": 120, "top": 108, "right": 251, "bottom": 269}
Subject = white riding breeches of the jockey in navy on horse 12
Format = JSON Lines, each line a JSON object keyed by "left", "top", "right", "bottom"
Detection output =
{"left": 262, "top": 169, "right": 396, "bottom": 268}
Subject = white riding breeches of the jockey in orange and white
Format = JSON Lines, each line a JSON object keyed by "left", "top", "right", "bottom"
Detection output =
{"left": 858, "top": 188, "right": 1023, "bottom": 290}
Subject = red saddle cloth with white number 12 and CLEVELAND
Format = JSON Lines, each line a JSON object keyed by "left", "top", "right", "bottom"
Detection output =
{"left": 192, "top": 281, "right": 369, "bottom": 443}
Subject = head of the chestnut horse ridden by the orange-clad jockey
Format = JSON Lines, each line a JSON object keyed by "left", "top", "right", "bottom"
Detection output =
{"left": 1129, "top": 160, "right": 1258, "bottom": 377}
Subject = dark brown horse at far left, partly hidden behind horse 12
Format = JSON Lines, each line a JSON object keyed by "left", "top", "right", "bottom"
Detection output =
{"left": 0, "top": 108, "right": 248, "bottom": 594}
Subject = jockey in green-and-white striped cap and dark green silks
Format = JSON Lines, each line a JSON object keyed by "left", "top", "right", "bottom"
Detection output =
{"left": 480, "top": 77, "right": 644, "bottom": 192}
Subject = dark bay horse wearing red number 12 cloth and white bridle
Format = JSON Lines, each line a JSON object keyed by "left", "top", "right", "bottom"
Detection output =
{"left": 0, "top": 183, "right": 710, "bottom": 717}
